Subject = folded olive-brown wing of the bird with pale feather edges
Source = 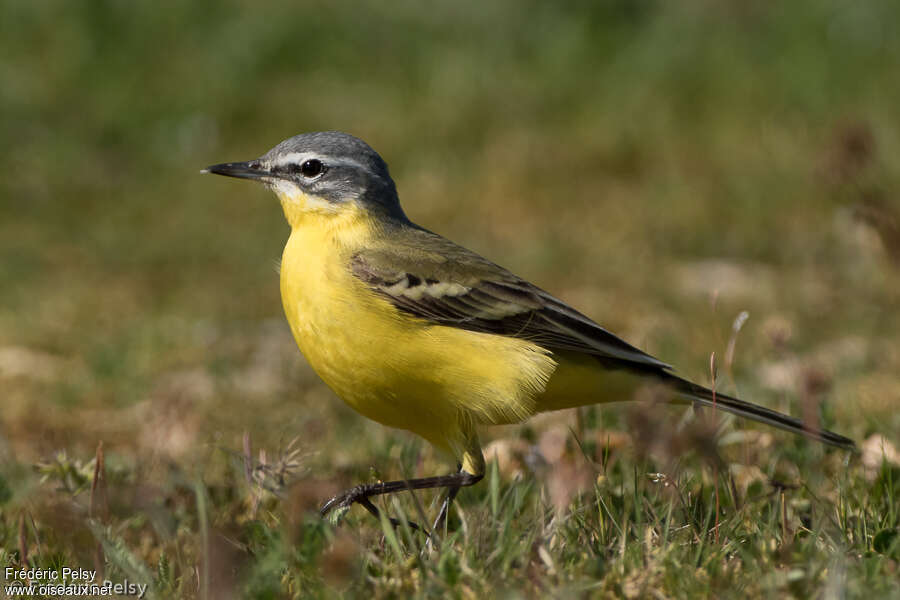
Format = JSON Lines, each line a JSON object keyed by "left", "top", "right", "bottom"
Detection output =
{"left": 350, "top": 228, "right": 670, "bottom": 373}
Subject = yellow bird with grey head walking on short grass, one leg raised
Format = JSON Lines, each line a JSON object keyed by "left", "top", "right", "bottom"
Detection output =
{"left": 203, "top": 131, "right": 855, "bottom": 531}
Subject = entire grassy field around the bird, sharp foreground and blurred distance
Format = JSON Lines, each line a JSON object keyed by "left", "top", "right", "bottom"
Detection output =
{"left": 0, "top": 1, "right": 900, "bottom": 598}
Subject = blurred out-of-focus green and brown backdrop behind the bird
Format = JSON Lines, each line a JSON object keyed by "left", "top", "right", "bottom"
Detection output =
{"left": 0, "top": 0, "right": 900, "bottom": 596}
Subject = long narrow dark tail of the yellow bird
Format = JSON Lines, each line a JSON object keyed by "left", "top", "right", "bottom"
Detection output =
{"left": 664, "top": 373, "right": 856, "bottom": 450}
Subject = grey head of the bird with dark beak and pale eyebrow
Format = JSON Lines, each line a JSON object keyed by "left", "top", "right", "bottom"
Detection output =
{"left": 204, "top": 131, "right": 405, "bottom": 219}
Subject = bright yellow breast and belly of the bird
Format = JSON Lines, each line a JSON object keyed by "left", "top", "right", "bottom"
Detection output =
{"left": 281, "top": 216, "right": 556, "bottom": 451}
